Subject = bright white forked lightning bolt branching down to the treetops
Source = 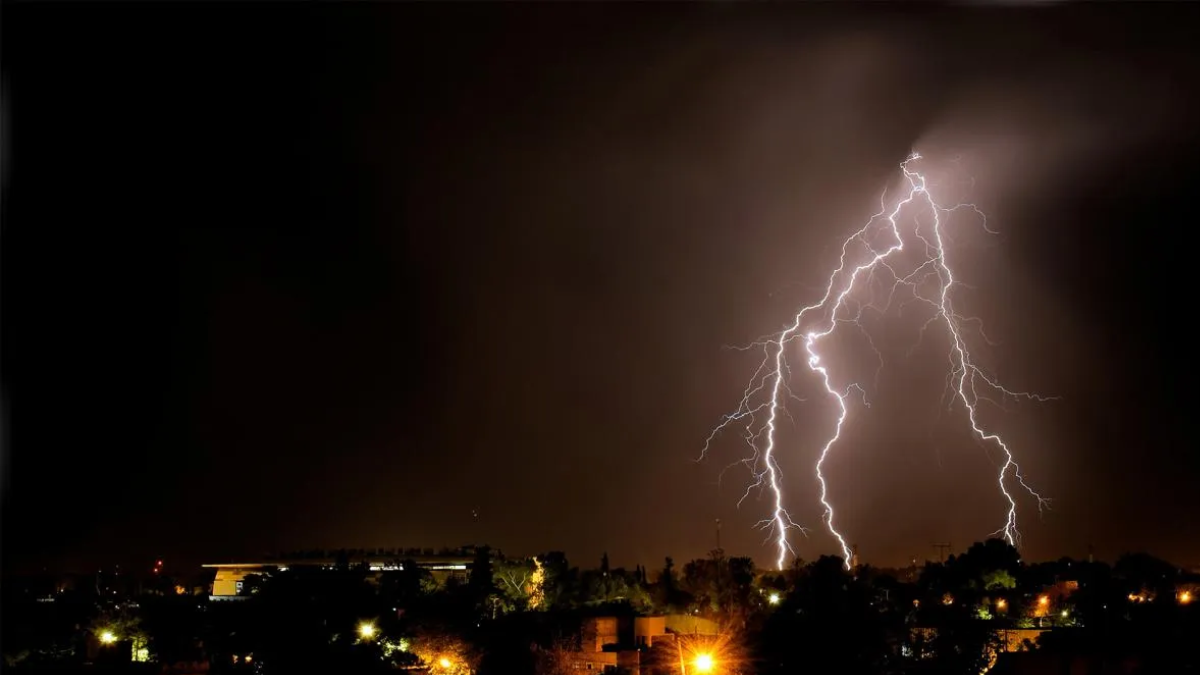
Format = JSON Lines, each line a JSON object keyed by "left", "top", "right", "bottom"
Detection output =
{"left": 701, "top": 154, "right": 1050, "bottom": 568}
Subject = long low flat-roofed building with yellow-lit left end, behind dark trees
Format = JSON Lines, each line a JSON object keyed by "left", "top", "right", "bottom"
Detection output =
{"left": 203, "top": 550, "right": 475, "bottom": 601}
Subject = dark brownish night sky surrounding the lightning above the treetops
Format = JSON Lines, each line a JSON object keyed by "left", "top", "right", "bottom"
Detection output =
{"left": 0, "top": 2, "right": 1200, "bottom": 568}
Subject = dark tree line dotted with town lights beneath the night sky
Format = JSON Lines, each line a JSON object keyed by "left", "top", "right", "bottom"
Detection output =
{"left": 4, "top": 539, "right": 1200, "bottom": 675}
